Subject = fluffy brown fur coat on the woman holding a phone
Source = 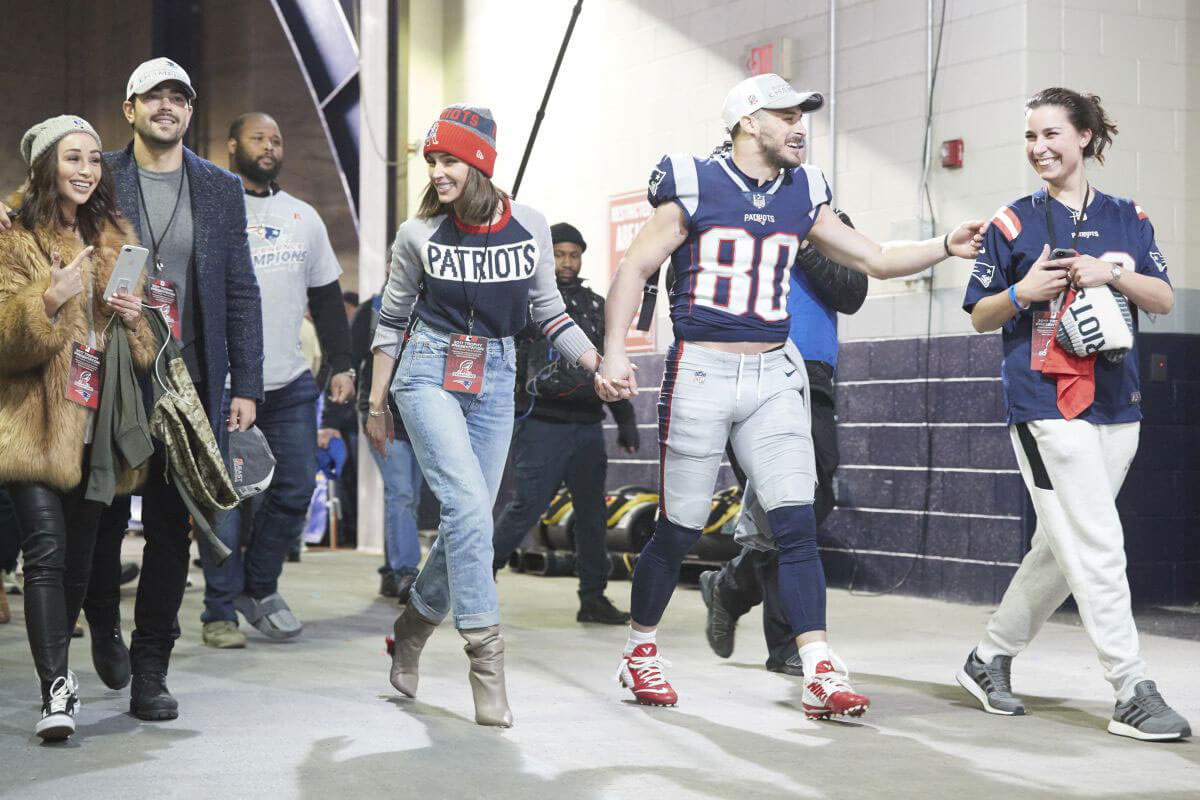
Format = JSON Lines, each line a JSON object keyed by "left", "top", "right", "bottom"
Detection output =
{"left": 0, "top": 194, "right": 157, "bottom": 494}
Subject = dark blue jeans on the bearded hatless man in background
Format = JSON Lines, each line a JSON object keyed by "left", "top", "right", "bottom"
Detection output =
{"left": 200, "top": 372, "right": 320, "bottom": 622}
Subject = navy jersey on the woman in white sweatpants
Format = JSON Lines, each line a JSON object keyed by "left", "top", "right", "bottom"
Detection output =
{"left": 962, "top": 188, "right": 1170, "bottom": 425}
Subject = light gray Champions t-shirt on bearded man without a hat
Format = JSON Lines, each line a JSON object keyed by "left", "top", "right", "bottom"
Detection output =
{"left": 234, "top": 190, "right": 342, "bottom": 391}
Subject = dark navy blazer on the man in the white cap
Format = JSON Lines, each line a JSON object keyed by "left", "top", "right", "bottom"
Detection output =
{"left": 104, "top": 143, "right": 263, "bottom": 432}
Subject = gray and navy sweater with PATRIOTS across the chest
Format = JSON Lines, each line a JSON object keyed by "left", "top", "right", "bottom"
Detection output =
{"left": 372, "top": 198, "right": 592, "bottom": 362}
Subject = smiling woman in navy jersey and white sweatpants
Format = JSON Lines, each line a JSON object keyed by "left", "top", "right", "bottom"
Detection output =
{"left": 958, "top": 89, "right": 1190, "bottom": 740}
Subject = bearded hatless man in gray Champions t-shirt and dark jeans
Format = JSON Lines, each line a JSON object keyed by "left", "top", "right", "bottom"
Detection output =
{"left": 200, "top": 113, "right": 354, "bottom": 649}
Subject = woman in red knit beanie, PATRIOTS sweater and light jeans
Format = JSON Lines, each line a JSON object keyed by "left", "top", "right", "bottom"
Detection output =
{"left": 367, "top": 106, "right": 607, "bottom": 727}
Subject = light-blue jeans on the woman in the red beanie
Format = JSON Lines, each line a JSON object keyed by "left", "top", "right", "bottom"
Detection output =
{"left": 391, "top": 323, "right": 516, "bottom": 630}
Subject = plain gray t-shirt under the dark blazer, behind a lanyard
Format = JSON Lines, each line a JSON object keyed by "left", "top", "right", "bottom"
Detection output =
{"left": 138, "top": 167, "right": 196, "bottom": 347}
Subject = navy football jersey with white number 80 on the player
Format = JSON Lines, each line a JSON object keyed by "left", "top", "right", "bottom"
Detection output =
{"left": 647, "top": 156, "right": 830, "bottom": 342}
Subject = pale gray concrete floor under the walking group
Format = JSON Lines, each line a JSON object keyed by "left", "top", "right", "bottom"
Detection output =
{"left": 0, "top": 552, "right": 1200, "bottom": 800}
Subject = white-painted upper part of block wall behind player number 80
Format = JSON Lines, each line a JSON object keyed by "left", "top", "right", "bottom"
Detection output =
{"left": 436, "top": 0, "right": 1200, "bottom": 347}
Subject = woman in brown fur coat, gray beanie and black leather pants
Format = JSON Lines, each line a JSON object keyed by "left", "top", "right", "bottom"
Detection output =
{"left": 0, "top": 116, "right": 155, "bottom": 739}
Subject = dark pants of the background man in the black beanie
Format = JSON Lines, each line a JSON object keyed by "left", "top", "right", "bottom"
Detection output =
{"left": 492, "top": 417, "right": 608, "bottom": 597}
